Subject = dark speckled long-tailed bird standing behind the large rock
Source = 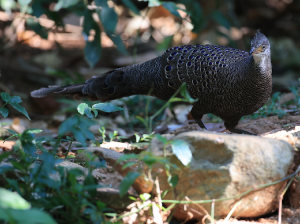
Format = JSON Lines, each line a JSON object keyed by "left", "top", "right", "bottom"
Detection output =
{"left": 31, "top": 30, "right": 272, "bottom": 135}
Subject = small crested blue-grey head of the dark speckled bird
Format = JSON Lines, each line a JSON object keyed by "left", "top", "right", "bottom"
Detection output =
{"left": 250, "top": 30, "right": 271, "bottom": 57}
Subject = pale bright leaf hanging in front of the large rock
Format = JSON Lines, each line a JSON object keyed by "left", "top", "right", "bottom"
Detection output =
{"left": 171, "top": 139, "right": 193, "bottom": 166}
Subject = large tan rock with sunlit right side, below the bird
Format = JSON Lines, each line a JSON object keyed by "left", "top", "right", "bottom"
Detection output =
{"left": 151, "top": 131, "right": 294, "bottom": 220}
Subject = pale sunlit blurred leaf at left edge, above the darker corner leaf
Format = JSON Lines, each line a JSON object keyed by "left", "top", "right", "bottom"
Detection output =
{"left": 0, "top": 188, "right": 30, "bottom": 210}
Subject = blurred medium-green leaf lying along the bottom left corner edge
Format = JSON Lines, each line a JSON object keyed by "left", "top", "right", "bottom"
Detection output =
{"left": 0, "top": 209, "right": 56, "bottom": 224}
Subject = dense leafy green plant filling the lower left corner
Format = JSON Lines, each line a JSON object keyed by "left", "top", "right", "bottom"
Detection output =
{"left": 0, "top": 95, "right": 107, "bottom": 224}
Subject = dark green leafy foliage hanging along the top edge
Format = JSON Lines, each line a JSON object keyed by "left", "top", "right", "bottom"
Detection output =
{"left": 0, "top": 0, "right": 231, "bottom": 68}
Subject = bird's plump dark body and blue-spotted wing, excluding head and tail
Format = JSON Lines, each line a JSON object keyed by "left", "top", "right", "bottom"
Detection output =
{"left": 162, "top": 45, "right": 272, "bottom": 117}
